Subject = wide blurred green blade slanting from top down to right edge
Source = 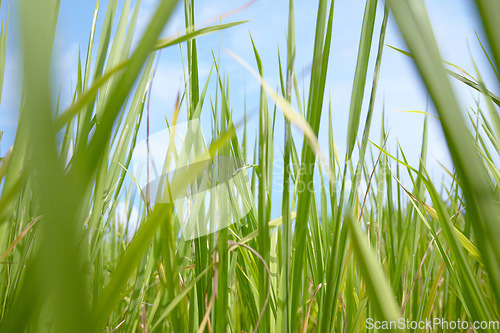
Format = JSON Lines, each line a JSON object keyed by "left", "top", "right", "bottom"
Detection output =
{"left": 389, "top": 0, "right": 500, "bottom": 306}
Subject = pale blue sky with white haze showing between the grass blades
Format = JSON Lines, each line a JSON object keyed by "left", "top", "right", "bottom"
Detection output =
{"left": 0, "top": 0, "right": 497, "bottom": 218}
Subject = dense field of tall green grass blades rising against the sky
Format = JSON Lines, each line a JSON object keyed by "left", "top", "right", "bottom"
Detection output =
{"left": 0, "top": 0, "right": 500, "bottom": 332}
